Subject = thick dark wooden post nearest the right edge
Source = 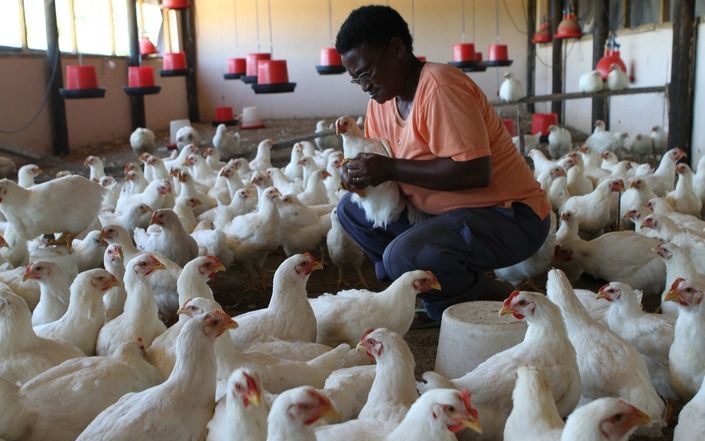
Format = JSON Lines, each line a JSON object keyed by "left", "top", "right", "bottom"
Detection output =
{"left": 668, "top": 0, "right": 697, "bottom": 158}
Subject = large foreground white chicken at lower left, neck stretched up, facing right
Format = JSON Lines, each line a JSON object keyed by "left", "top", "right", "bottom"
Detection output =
{"left": 76, "top": 311, "right": 237, "bottom": 441}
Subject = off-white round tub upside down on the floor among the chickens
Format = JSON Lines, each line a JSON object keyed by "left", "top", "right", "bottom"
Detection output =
{"left": 435, "top": 301, "right": 527, "bottom": 378}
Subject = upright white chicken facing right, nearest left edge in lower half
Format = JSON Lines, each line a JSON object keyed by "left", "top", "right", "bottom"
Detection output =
{"left": 34, "top": 269, "right": 118, "bottom": 355}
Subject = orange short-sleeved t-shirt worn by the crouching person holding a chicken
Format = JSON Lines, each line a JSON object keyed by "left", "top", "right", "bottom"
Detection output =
{"left": 365, "top": 63, "right": 550, "bottom": 219}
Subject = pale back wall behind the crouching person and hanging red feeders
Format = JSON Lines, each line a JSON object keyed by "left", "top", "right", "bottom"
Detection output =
{"left": 196, "top": 0, "right": 526, "bottom": 120}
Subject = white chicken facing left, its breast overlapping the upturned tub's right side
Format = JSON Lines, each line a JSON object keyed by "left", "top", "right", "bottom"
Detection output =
{"left": 423, "top": 291, "right": 581, "bottom": 440}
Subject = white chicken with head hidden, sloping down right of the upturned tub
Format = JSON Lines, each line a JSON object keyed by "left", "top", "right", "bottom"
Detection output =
{"left": 546, "top": 269, "right": 664, "bottom": 430}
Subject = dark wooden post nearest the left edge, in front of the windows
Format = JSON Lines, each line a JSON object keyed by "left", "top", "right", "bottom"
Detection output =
{"left": 44, "top": 0, "right": 69, "bottom": 155}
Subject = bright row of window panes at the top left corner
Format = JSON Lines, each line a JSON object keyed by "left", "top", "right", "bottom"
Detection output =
{"left": 0, "top": 0, "right": 180, "bottom": 55}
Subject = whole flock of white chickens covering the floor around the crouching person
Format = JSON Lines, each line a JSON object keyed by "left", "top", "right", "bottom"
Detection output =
{"left": 0, "top": 112, "right": 705, "bottom": 441}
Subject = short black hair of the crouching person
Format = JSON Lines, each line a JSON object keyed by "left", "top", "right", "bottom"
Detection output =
{"left": 335, "top": 5, "right": 413, "bottom": 54}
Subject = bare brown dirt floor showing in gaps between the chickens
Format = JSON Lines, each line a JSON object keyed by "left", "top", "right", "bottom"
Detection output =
{"left": 20, "top": 118, "right": 672, "bottom": 441}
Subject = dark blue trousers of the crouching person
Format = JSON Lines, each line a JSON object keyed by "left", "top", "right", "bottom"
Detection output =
{"left": 338, "top": 193, "right": 550, "bottom": 320}
